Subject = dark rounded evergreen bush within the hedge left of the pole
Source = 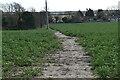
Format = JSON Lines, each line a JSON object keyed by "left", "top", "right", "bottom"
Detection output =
{"left": 18, "top": 12, "right": 36, "bottom": 30}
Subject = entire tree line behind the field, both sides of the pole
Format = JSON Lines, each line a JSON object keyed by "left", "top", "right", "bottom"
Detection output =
{"left": 0, "top": 2, "right": 120, "bottom": 30}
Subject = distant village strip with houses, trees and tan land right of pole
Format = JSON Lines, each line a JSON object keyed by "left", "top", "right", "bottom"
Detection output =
{"left": 49, "top": 9, "right": 120, "bottom": 23}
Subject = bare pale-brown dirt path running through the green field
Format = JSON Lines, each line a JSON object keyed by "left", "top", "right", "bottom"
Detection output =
{"left": 36, "top": 32, "right": 93, "bottom": 78}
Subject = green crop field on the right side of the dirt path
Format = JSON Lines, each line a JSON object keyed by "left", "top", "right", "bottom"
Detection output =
{"left": 51, "top": 22, "right": 119, "bottom": 78}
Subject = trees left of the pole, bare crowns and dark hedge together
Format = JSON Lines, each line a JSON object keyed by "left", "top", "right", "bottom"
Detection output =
{"left": 1, "top": 2, "right": 46, "bottom": 30}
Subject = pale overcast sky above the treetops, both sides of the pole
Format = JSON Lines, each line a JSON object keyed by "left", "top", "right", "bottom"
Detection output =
{"left": 0, "top": 0, "right": 120, "bottom": 11}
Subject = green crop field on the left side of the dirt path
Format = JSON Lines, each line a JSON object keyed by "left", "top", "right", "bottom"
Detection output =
{"left": 2, "top": 29, "right": 60, "bottom": 78}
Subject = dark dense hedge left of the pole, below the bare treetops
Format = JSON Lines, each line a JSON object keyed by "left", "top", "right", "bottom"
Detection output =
{"left": 2, "top": 12, "right": 46, "bottom": 30}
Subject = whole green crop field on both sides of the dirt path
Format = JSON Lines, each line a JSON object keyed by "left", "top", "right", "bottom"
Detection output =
{"left": 2, "top": 23, "right": 119, "bottom": 78}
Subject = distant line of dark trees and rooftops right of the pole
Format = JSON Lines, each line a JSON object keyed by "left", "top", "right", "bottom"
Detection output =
{"left": 51, "top": 8, "right": 120, "bottom": 23}
